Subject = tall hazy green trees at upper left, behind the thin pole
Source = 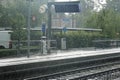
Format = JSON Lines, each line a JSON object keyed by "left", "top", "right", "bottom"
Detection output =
{"left": 0, "top": 0, "right": 47, "bottom": 40}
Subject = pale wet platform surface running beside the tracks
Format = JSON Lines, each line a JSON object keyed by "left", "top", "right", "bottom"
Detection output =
{"left": 0, "top": 48, "right": 120, "bottom": 67}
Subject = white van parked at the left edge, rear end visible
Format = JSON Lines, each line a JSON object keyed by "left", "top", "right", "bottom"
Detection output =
{"left": 0, "top": 31, "right": 12, "bottom": 49}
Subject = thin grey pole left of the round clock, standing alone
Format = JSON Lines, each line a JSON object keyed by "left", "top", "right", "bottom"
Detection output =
{"left": 27, "top": 0, "right": 31, "bottom": 58}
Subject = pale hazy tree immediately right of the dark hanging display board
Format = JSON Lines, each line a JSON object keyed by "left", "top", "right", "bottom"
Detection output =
{"left": 75, "top": 0, "right": 98, "bottom": 27}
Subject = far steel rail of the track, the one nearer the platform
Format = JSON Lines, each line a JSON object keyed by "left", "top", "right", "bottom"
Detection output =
{"left": 24, "top": 57, "right": 120, "bottom": 80}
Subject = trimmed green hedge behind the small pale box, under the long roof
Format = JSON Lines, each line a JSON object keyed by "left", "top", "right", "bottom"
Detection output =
{"left": 54, "top": 31, "right": 102, "bottom": 48}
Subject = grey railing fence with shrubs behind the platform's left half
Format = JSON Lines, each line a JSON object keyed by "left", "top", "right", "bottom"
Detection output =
{"left": 0, "top": 40, "right": 57, "bottom": 57}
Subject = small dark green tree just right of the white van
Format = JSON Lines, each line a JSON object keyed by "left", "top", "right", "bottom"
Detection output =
{"left": 10, "top": 13, "right": 26, "bottom": 41}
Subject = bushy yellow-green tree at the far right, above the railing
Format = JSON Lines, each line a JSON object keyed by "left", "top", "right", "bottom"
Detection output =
{"left": 86, "top": 9, "right": 120, "bottom": 38}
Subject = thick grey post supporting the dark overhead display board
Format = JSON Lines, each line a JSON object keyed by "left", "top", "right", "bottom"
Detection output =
{"left": 47, "top": 3, "right": 52, "bottom": 54}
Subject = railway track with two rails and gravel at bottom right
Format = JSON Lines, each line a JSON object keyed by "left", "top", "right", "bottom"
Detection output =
{"left": 24, "top": 61, "right": 120, "bottom": 80}
